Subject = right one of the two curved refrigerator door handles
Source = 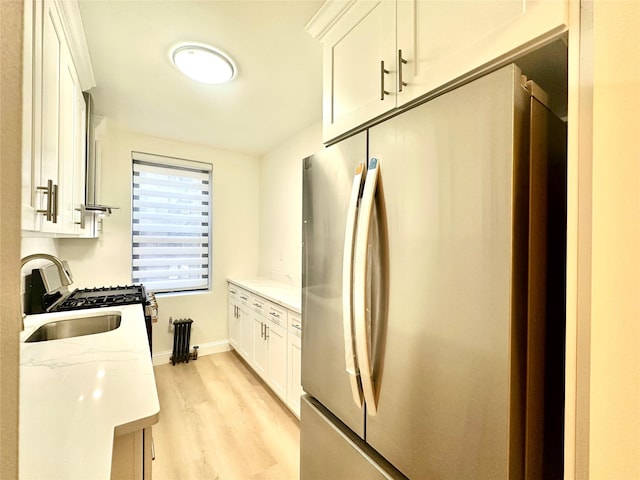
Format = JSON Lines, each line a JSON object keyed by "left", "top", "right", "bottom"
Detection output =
{"left": 353, "top": 157, "right": 379, "bottom": 415}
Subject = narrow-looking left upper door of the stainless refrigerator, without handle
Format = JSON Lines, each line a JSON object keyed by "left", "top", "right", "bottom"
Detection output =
{"left": 302, "top": 132, "right": 367, "bottom": 437}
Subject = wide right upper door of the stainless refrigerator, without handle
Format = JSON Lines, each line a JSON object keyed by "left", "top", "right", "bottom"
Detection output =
{"left": 366, "top": 66, "right": 528, "bottom": 480}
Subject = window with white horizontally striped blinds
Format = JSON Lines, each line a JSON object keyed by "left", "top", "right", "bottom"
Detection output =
{"left": 131, "top": 152, "right": 211, "bottom": 292}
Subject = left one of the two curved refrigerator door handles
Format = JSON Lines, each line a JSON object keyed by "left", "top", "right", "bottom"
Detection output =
{"left": 342, "top": 162, "right": 365, "bottom": 407}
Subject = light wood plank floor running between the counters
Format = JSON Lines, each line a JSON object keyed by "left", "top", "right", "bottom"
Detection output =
{"left": 153, "top": 352, "right": 300, "bottom": 480}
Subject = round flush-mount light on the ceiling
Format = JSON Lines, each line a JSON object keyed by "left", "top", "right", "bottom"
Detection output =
{"left": 171, "top": 43, "right": 236, "bottom": 84}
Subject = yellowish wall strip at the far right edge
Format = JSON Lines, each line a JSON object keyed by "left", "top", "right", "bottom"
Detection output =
{"left": 589, "top": 1, "right": 640, "bottom": 480}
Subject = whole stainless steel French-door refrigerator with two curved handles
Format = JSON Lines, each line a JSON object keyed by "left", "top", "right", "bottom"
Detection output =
{"left": 300, "top": 65, "right": 566, "bottom": 480}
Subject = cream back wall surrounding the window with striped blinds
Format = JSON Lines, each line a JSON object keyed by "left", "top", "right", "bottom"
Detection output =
{"left": 57, "top": 120, "right": 260, "bottom": 360}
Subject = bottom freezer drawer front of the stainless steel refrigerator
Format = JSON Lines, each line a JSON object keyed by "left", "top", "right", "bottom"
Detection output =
{"left": 300, "top": 396, "right": 406, "bottom": 480}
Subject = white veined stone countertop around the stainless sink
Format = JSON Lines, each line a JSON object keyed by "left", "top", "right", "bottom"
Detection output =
{"left": 20, "top": 305, "right": 160, "bottom": 480}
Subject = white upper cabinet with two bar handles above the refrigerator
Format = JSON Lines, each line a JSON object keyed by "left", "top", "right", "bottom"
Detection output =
{"left": 307, "top": 0, "right": 568, "bottom": 142}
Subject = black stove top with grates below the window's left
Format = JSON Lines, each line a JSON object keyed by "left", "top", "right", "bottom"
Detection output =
{"left": 53, "top": 285, "right": 147, "bottom": 312}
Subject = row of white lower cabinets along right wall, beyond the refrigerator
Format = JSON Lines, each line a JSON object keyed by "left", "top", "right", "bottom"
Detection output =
{"left": 228, "top": 282, "right": 302, "bottom": 417}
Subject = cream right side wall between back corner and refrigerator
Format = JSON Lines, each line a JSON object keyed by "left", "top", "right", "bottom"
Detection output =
{"left": 258, "top": 121, "right": 323, "bottom": 286}
